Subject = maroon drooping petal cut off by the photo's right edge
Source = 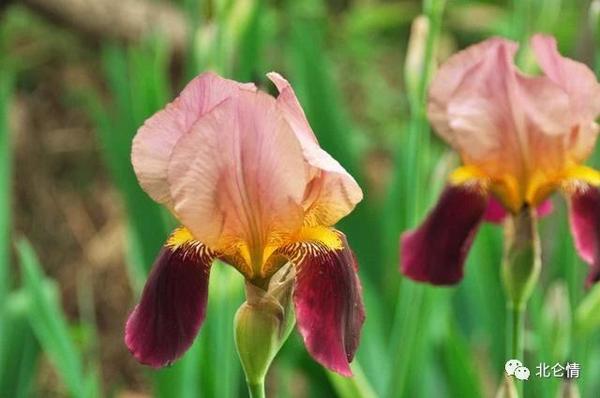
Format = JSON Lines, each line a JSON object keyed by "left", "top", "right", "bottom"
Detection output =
{"left": 570, "top": 186, "right": 600, "bottom": 285}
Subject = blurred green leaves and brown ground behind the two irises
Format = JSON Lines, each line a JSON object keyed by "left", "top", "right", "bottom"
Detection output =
{"left": 0, "top": 0, "right": 600, "bottom": 398}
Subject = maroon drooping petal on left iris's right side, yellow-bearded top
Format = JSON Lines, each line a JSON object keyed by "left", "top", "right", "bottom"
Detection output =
{"left": 293, "top": 233, "right": 365, "bottom": 376}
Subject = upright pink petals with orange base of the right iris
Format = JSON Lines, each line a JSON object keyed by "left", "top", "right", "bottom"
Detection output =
{"left": 428, "top": 36, "right": 600, "bottom": 211}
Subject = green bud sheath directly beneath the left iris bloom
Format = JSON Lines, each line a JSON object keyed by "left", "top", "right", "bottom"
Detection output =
{"left": 234, "top": 265, "right": 295, "bottom": 386}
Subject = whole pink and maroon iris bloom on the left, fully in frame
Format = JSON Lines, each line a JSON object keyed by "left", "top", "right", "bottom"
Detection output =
{"left": 125, "top": 73, "right": 364, "bottom": 376}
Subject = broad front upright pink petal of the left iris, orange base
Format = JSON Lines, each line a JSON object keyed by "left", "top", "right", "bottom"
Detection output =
{"left": 168, "top": 91, "right": 308, "bottom": 252}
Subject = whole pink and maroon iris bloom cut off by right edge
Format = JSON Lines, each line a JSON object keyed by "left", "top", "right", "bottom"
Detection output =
{"left": 401, "top": 35, "right": 600, "bottom": 285}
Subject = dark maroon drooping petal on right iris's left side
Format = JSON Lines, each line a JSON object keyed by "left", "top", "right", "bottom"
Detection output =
{"left": 401, "top": 184, "right": 488, "bottom": 285}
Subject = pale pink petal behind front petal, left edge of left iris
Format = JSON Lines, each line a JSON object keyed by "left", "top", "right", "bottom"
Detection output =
{"left": 131, "top": 72, "right": 256, "bottom": 207}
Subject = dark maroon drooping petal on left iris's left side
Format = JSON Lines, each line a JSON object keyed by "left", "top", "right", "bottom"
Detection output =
{"left": 125, "top": 243, "right": 213, "bottom": 368}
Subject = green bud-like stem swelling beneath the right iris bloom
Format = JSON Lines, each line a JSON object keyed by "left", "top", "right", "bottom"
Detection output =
{"left": 502, "top": 207, "right": 541, "bottom": 310}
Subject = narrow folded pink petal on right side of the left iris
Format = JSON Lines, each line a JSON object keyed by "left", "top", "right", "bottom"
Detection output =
{"left": 267, "top": 72, "right": 363, "bottom": 225}
